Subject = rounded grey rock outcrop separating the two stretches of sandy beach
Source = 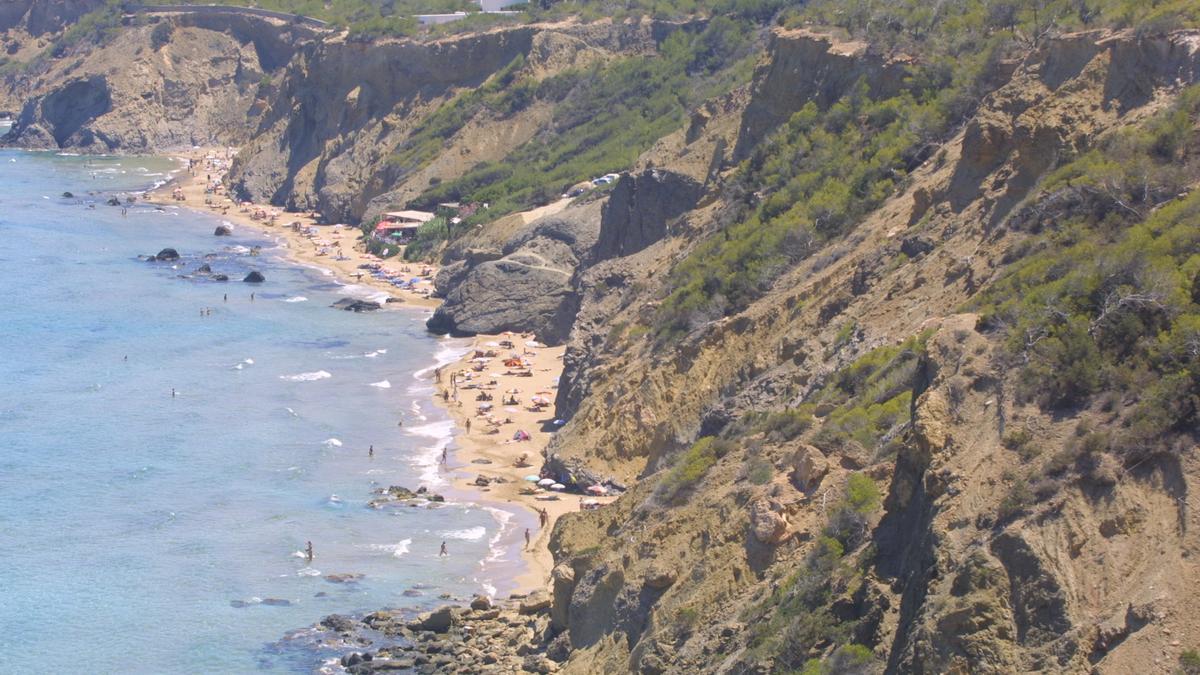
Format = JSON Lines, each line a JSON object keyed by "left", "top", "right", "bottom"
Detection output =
{"left": 426, "top": 204, "right": 600, "bottom": 345}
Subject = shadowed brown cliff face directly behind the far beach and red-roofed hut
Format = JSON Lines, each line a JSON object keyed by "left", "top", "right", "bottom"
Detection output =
{"left": 225, "top": 22, "right": 661, "bottom": 222}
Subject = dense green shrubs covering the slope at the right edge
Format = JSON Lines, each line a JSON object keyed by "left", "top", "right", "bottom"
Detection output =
{"left": 976, "top": 88, "right": 1200, "bottom": 460}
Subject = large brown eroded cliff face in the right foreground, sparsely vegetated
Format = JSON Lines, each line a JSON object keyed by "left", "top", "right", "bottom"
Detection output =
{"left": 535, "top": 26, "right": 1200, "bottom": 673}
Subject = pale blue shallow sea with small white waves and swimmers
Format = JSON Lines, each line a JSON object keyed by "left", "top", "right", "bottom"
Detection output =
{"left": 0, "top": 151, "right": 527, "bottom": 673}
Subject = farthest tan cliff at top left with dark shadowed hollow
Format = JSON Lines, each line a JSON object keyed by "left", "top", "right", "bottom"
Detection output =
{"left": 4, "top": 16, "right": 313, "bottom": 153}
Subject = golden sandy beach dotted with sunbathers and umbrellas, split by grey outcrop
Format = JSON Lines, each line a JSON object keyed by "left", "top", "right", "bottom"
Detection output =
{"left": 145, "top": 149, "right": 600, "bottom": 593}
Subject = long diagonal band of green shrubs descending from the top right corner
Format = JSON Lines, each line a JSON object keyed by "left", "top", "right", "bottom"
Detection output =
{"left": 659, "top": 0, "right": 1200, "bottom": 338}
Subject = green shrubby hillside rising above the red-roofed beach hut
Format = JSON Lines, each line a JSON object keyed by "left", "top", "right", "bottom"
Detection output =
{"left": 408, "top": 19, "right": 751, "bottom": 219}
